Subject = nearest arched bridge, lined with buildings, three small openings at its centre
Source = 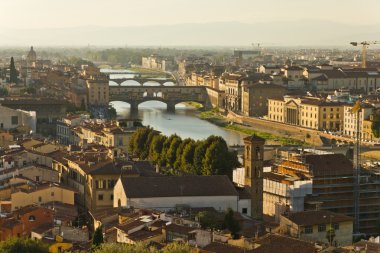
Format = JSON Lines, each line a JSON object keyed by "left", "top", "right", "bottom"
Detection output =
{"left": 109, "top": 86, "right": 212, "bottom": 113}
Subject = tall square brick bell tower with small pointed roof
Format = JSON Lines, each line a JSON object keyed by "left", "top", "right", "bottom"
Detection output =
{"left": 244, "top": 135, "right": 265, "bottom": 219}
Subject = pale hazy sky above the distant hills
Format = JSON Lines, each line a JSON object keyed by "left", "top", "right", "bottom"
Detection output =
{"left": 0, "top": 0, "right": 380, "bottom": 29}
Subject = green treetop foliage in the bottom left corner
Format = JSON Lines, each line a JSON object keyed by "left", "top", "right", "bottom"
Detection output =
{"left": 0, "top": 238, "right": 49, "bottom": 253}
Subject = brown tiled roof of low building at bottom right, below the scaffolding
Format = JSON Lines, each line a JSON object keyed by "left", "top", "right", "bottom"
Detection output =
{"left": 283, "top": 210, "right": 353, "bottom": 226}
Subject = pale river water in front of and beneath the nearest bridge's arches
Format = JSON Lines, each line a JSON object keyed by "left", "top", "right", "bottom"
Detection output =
{"left": 111, "top": 101, "right": 244, "bottom": 145}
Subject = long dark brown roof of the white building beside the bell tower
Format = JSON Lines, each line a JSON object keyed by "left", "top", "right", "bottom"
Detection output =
{"left": 121, "top": 176, "right": 238, "bottom": 198}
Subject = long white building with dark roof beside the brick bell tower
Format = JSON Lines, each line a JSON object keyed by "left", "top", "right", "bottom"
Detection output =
{"left": 114, "top": 176, "right": 249, "bottom": 212}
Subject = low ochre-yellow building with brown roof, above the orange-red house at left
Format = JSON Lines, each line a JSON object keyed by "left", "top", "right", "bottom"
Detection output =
{"left": 11, "top": 183, "right": 74, "bottom": 211}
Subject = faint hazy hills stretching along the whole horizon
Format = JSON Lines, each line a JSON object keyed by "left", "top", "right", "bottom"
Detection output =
{"left": 0, "top": 20, "right": 380, "bottom": 46}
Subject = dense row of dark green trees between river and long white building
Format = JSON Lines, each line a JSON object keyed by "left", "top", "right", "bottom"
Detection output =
{"left": 129, "top": 128, "right": 240, "bottom": 176}
